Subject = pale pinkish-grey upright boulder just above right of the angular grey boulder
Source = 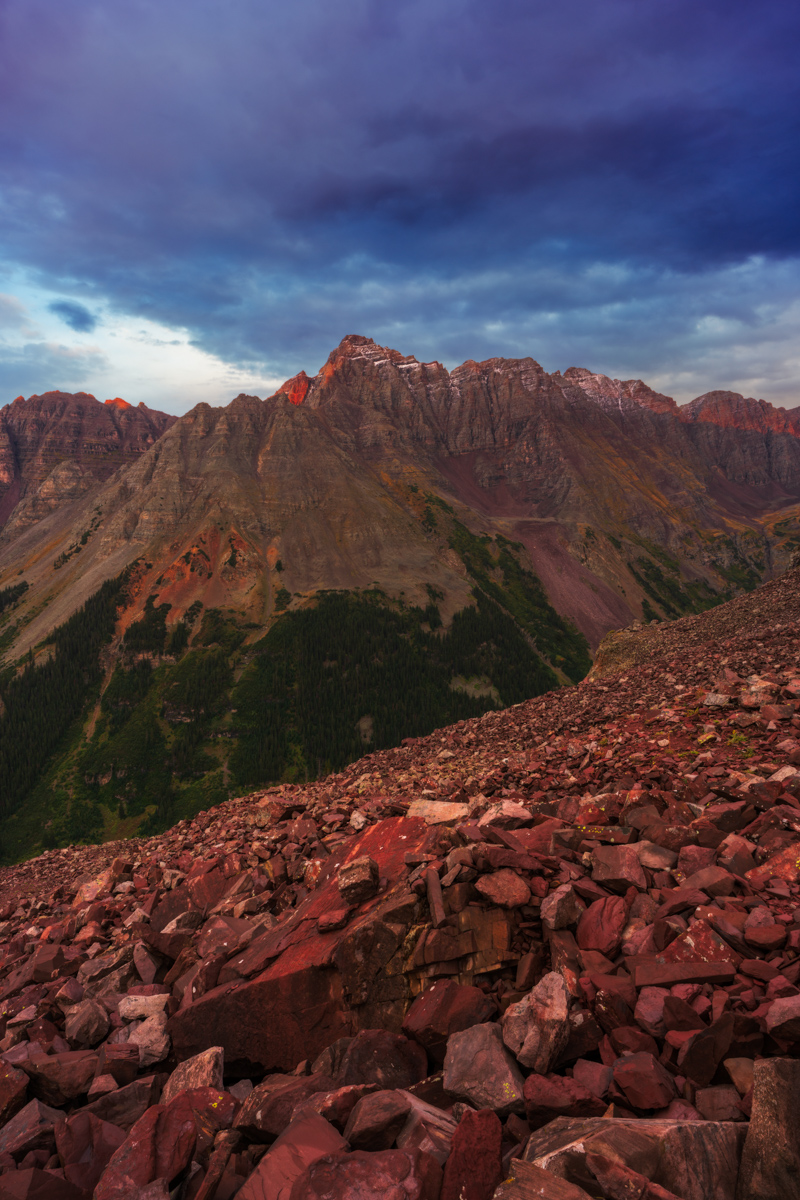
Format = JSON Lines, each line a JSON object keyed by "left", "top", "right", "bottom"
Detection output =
{"left": 501, "top": 971, "right": 570, "bottom": 1075}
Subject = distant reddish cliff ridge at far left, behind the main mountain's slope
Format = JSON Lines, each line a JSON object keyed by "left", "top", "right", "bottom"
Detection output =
{"left": 0, "top": 391, "right": 176, "bottom": 539}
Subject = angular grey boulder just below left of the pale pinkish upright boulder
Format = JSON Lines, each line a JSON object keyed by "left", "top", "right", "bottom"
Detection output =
{"left": 444, "top": 1022, "right": 524, "bottom": 1117}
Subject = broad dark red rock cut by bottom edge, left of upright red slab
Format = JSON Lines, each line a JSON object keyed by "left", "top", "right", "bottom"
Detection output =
{"left": 291, "top": 1150, "right": 441, "bottom": 1200}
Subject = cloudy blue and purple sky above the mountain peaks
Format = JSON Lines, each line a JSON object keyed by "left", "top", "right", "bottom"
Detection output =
{"left": 0, "top": 0, "right": 800, "bottom": 413}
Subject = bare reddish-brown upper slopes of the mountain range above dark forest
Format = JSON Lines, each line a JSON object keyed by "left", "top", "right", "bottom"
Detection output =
{"left": 0, "top": 336, "right": 800, "bottom": 662}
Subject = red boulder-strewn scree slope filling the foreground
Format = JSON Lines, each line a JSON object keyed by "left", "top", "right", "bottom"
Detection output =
{"left": 0, "top": 570, "right": 800, "bottom": 1200}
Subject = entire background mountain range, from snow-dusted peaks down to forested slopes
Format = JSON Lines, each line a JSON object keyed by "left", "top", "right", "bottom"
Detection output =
{"left": 0, "top": 336, "right": 800, "bottom": 860}
